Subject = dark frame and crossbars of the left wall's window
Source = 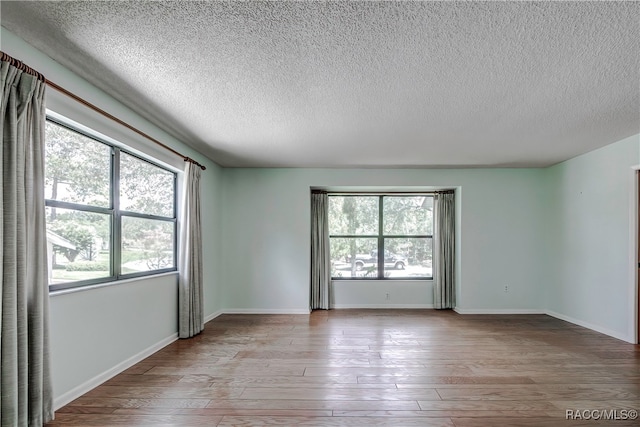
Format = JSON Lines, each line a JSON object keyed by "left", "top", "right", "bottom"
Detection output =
{"left": 44, "top": 113, "right": 179, "bottom": 292}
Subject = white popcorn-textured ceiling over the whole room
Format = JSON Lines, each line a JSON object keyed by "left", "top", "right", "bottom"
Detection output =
{"left": 1, "top": 0, "right": 640, "bottom": 167}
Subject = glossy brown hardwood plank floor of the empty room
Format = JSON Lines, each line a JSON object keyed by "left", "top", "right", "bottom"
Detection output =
{"left": 48, "top": 310, "right": 640, "bottom": 427}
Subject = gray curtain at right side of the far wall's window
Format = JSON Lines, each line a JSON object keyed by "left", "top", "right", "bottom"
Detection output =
{"left": 433, "top": 192, "right": 456, "bottom": 309}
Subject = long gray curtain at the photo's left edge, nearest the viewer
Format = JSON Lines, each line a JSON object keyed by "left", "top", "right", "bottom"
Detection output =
{"left": 0, "top": 55, "right": 53, "bottom": 427}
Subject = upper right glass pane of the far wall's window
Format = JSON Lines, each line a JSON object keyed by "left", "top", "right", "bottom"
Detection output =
{"left": 382, "top": 196, "right": 433, "bottom": 235}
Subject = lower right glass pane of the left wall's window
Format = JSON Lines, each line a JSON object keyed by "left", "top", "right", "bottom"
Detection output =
{"left": 122, "top": 216, "right": 175, "bottom": 274}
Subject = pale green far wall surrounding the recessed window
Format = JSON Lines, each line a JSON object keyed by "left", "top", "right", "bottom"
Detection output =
{"left": 222, "top": 169, "right": 546, "bottom": 311}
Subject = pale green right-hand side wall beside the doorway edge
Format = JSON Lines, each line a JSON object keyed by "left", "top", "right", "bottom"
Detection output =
{"left": 545, "top": 135, "right": 640, "bottom": 340}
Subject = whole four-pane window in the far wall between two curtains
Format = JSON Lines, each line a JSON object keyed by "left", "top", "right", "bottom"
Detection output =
{"left": 329, "top": 194, "right": 433, "bottom": 279}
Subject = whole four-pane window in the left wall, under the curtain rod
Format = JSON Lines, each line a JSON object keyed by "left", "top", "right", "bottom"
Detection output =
{"left": 45, "top": 119, "right": 176, "bottom": 290}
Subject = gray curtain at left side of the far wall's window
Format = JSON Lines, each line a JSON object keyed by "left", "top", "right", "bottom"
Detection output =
{"left": 310, "top": 191, "right": 331, "bottom": 310}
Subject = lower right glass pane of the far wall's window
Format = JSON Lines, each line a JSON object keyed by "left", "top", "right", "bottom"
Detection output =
{"left": 384, "top": 237, "right": 433, "bottom": 278}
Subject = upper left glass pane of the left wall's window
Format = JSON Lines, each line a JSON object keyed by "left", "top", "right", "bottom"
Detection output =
{"left": 45, "top": 122, "right": 111, "bottom": 207}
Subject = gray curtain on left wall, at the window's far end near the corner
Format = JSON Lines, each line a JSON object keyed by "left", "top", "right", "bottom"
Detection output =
{"left": 178, "top": 162, "right": 204, "bottom": 338}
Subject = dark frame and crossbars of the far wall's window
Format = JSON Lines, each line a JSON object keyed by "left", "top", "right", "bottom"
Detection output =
{"left": 327, "top": 191, "right": 436, "bottom": 281}
